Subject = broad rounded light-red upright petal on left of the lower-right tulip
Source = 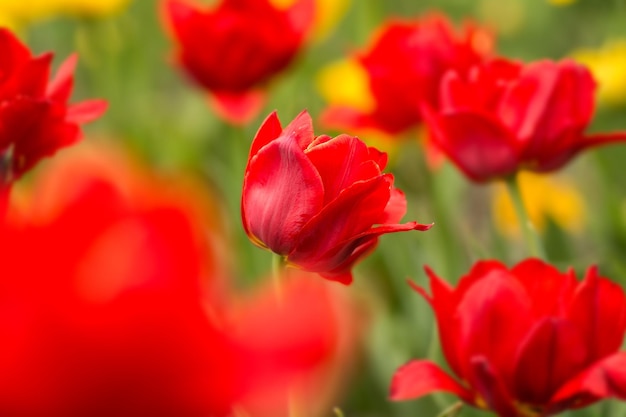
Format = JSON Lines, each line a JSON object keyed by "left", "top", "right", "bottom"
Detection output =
{"left": 456, "top": 270, "right": 533, "bottom": 384}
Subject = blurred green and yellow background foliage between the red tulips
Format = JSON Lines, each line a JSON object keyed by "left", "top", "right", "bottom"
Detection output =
{"left": 7, "top": 0, "right": 626, "bottom": 417}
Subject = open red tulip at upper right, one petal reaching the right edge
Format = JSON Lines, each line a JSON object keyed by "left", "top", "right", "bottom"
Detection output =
{"left": 425, "top": 59, "right": 626, "bottom": 182}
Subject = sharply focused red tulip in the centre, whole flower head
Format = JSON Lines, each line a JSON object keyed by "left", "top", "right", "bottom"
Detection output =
{"left": 241, "top": 111, "right": 430, "bottom": 284}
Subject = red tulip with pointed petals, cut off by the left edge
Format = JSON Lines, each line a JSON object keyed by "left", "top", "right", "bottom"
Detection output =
{"left": 0, "top": 28, "right": 106, "bottom": 180}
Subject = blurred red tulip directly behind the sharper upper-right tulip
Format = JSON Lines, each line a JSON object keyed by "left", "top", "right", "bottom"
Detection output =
{"left": 322, "top": 14, "right": 493, "bottom": 135}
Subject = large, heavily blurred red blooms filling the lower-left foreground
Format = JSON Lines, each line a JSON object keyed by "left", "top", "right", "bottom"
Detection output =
{"left": 0, "top": 146, "right": 358, "bottom": 417}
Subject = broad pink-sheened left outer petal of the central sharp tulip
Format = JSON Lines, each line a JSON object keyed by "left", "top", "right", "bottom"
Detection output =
{"left": 242, "top": 138, "right": 324, "bottom": 255}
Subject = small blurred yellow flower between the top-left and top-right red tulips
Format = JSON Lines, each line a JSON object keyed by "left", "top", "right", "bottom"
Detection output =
{"left": 317, "top": 59, "right": 376, "bottom": 112}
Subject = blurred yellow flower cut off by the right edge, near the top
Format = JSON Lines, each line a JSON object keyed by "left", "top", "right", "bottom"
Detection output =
{"left": 571, "top": 39, "right": 626, "bottom": 105}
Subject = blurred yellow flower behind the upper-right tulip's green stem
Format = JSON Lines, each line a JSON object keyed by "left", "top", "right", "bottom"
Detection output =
{"left": 492, "top": 172, "right": 585, "bottom": 236}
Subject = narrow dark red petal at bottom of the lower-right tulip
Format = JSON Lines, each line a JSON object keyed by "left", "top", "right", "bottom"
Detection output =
{"left": 470, "top": 356, "right": 518, "bottom": 417}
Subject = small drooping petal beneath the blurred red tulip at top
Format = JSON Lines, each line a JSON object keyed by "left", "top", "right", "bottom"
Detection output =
{"left": 209, "top": 90, "right": 266, "bottom": 126}
